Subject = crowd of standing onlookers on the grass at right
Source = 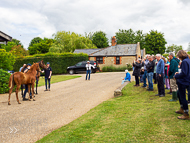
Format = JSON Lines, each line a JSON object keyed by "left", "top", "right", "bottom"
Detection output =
{"left": 133, "top": 50, "right": 190, "bottom": 120}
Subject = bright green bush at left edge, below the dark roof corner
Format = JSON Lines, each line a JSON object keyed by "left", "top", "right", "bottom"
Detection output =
{"left": 0, "top": 49, "right": 15, "bottom": 70}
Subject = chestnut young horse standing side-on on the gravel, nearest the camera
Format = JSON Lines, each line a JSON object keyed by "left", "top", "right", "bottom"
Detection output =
{"left": 8, "top": 63, "right": 41, "bottom": 105}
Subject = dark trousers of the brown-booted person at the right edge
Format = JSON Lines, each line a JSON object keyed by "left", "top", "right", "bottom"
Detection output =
{"left": 177, "top": 83, "right": 190, "bottom": 113}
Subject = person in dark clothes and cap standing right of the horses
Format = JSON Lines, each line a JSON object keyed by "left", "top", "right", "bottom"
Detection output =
{"left": 42, "top": 62, "right": 52, "bottom": 91}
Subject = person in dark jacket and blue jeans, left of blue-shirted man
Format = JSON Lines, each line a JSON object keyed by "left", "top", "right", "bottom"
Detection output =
{"left": 146, "top": 56, "right": 155, "bottom": 91}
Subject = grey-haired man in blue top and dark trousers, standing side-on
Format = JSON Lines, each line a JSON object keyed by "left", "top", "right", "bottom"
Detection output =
{"left": 156, "top": 54, "right": 165, "bottom": 97}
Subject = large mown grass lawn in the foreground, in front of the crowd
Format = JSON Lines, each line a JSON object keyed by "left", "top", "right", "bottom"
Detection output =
{"left": 38, "top": 82, "right": 190, "bottom": 143}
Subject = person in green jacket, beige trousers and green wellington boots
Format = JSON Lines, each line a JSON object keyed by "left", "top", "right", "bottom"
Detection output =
{"left": 168, "top": 52, "right": 178, "bottom": 101}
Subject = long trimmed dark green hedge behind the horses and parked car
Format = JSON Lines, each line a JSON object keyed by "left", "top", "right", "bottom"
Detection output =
{"left": 13, "top": 53, "right": 88, "bottom": 74}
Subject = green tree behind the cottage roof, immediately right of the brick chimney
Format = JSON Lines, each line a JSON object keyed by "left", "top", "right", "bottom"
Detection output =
{"left": 116, "top": 29, "right": 145, "bottom": 49}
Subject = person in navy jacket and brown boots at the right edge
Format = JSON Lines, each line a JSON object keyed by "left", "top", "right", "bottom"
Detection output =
{"left": 174, "top": 50, "right": 190, "bottom": 120}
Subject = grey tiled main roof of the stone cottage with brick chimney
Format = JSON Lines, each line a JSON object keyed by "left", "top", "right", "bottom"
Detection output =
{"left": 90, "top": 44, "right": 137, "bottom": 56}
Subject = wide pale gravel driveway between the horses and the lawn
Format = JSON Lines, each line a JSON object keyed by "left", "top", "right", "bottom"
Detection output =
{"left": 0, "top": 72, "right": 134, "bottom": 143}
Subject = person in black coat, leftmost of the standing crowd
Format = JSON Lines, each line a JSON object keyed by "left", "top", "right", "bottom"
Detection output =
{"left": 133, "top": 59, "right": 142, "bottom": 86}
